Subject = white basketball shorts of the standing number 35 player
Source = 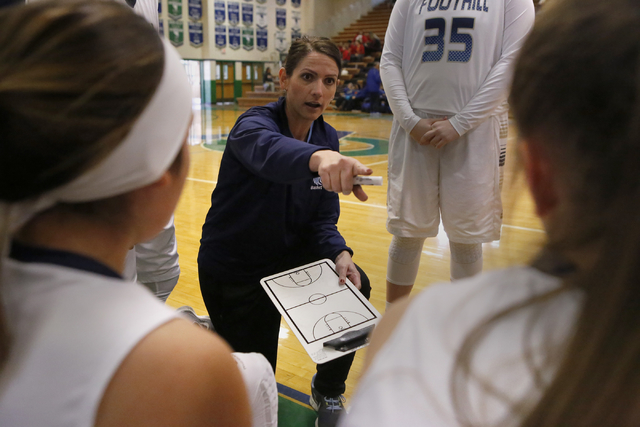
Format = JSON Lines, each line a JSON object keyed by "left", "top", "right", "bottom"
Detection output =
{"left": 387, "top": 114, "right": 502, "bottom": 243}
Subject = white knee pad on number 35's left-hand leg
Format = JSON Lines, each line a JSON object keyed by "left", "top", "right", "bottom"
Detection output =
{"left": 387, "top": 236, "right": 425, "bottom": 286}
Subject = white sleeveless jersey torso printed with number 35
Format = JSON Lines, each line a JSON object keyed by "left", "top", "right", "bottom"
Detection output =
{"left": 402, "top": 0, "right": 504, "bottom": 114}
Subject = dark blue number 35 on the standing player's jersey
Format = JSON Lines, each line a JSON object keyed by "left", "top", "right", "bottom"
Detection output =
{"left": 422, "top": 18, "right": 475, "bottom": 62}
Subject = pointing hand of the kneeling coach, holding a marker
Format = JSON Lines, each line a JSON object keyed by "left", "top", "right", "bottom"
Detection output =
{"left": 309, "top": 150, "right": 373, "bottom": 202}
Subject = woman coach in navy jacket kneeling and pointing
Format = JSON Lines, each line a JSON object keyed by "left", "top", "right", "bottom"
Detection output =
{"left": 198, "top": 37, "right": 371, "bottom": 426}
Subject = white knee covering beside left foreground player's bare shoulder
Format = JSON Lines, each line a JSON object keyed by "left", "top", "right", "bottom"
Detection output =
{"left": 232, "top": 353, "right": 278, "bottom": 427}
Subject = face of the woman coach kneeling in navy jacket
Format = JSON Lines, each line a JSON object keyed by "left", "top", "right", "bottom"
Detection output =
{"left": 280, "top": 52, "right": 339, "bottom": 124}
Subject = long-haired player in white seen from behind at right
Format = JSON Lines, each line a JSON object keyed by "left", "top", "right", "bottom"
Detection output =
{"left": 340, "top": 0, "right": 640, "bottom": 427}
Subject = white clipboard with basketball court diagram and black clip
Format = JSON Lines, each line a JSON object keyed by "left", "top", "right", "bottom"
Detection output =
{"left": 260, "top": 259, "right": 381, "bottom": 363}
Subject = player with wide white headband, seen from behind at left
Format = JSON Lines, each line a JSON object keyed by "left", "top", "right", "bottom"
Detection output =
{"left": 0, "top": 0, "right": 255, "bottom": 427}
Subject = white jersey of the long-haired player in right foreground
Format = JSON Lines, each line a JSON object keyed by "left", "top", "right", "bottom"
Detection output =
{"left": 339, "top": 267, "right": 581, "bottom": 427}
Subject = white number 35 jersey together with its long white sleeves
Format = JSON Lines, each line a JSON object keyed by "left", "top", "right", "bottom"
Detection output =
{"left": 380, "top": 0, "right": 535, "bottom": 135}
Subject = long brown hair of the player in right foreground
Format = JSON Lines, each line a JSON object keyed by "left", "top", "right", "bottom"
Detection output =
{"left": 453, "top": 0, "right": 640, "bottom": 427}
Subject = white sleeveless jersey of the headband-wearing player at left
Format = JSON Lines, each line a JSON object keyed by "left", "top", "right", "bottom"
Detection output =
{"left": 0, "top": 259, "right": 176, "bottom": 427}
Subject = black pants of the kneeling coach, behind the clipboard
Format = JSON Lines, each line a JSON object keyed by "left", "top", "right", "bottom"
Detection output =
{"left": 198, "top": 253, "right": 371, "bottom": 396}
